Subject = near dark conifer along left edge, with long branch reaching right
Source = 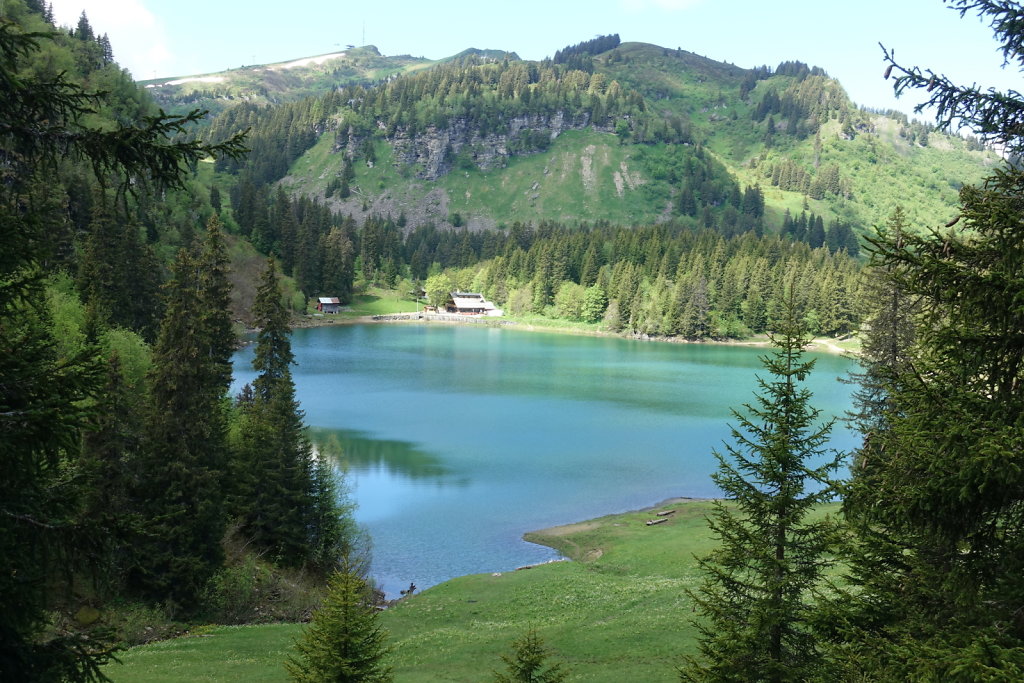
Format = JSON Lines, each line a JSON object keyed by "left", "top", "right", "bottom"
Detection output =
{"left": 0, "top": 17, "right": 238, "bottom": 680}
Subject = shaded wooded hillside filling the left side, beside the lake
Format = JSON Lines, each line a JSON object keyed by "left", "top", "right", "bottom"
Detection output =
{"left": 0, "top": 0, "right": 365, "bottom": 681}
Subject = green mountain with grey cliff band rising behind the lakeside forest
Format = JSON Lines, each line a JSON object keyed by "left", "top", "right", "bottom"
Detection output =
{"left": 147, "top": 37, "right": 998, "bottom": 236}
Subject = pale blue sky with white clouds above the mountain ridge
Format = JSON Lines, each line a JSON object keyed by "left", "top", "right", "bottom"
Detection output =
{"left": 46, "top": 0, "right": 1022, "bottom": 118}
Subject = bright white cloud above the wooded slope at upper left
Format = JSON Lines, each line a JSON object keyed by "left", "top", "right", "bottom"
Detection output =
{"left": 52, "top": 0, "right": 175, "bottom": 80}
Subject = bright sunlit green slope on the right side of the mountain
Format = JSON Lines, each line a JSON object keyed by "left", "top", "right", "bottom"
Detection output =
{"left": 597, "top": 44, "right": 998, "bottom": 228}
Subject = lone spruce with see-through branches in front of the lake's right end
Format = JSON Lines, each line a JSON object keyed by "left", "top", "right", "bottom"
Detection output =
{"left": 680, "top": 294, "right": 842, "bottom": 681}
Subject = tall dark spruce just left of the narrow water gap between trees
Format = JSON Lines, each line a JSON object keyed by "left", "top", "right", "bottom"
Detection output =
{"left": 132, "top": 218, "right": 234, "bottom": 611}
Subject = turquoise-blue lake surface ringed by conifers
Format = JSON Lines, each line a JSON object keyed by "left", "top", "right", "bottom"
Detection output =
{"left": 233, "top": 325, "right": 855, "bottom": 597}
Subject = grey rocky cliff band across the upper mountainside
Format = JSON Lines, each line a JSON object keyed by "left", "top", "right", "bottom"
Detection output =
{"left": 336, "top": 112, "right": 612, "bottom": 180}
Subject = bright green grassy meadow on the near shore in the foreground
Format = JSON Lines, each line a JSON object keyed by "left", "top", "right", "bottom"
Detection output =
{"left": 105, "top": 501, "right": 761, "bottom": 683}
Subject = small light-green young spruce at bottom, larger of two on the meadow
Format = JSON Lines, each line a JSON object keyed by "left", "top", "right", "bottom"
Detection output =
{"left": 285, "top": 559, "right": 392, "bottom": 683}
